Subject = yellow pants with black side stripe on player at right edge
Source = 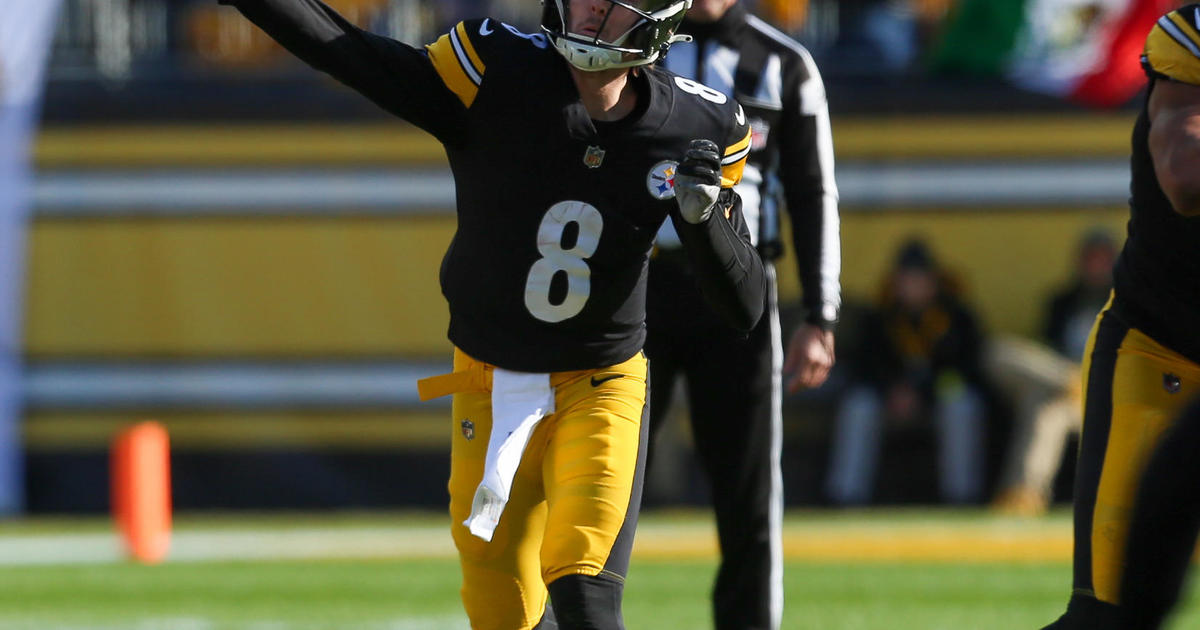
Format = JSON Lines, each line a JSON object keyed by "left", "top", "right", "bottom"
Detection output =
{"left": 1074, "top": 302, "right": 1200, "bottom": 604}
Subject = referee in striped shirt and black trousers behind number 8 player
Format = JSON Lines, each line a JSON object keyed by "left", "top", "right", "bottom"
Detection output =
{"left": 646, "top": 0, "right": 841, "bottom": 630}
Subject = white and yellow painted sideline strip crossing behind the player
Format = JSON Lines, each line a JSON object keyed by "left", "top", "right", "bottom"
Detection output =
{"left": 0, "top": 510, "right": 1072, "bottom": 566}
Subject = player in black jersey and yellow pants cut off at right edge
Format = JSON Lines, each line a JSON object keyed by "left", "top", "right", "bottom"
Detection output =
{"left": 1048, "top": 5, "right": 1200, "bottom": 630}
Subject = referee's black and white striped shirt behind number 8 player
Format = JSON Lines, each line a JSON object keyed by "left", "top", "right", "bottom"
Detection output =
{"left": 660, "top": 2, "right": 841, "bottom": 325}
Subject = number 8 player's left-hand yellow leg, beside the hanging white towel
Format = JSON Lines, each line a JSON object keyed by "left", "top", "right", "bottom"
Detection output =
{"left": 449, "top": 353, "right": 552, "bottom": 630}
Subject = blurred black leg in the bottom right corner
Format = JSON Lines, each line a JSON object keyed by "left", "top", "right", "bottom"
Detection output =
{"left": 1121, "top": 398, "right": 1200, "bottom": 630}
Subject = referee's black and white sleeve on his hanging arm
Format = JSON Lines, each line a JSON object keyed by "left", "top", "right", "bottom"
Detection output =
{"left": 773, "top": 54, "right": 841, "bottom": 329}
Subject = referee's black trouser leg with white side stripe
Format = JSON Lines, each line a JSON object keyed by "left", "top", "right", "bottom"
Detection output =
{"left": 686, "top": 268, "right": 784, "bottom": 630}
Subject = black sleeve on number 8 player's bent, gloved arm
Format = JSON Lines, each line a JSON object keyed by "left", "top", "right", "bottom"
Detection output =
{"left": 671, "top": 190, "right": 767, "bottom": 331}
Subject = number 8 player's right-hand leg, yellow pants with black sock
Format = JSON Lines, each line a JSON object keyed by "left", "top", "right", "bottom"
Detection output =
{"left": 541, "top": 354, "right": 649, "bottom": 630}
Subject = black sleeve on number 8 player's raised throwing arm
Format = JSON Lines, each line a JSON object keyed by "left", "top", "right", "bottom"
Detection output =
{"left": 218, "top": 0, "right": 466, "bottom": 144}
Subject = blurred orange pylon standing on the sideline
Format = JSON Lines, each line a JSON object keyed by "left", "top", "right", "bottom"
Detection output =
{"left": 109, "top": 422, "right": 170, "bottom": 564}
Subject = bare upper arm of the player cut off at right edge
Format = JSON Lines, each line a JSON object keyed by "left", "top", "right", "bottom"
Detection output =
{"left": 1148, "top": 80, "right": 1200, "bottom": 216}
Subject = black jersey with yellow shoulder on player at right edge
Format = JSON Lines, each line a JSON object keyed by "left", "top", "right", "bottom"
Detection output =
{"left": 1114, "top": 5, "right": 1200, "bottom": 362}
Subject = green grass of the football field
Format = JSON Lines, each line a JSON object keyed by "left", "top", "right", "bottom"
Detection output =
{"left": 0, "top": 512, "right": 1200, "bottom": 630}
